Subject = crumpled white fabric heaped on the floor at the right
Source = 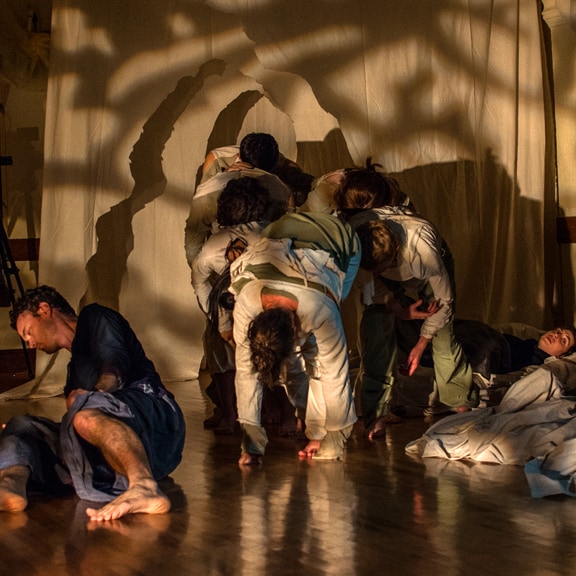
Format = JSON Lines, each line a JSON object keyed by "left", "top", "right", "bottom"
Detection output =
{"left": 406, "top": 368, "right": 576, "bottom": 497}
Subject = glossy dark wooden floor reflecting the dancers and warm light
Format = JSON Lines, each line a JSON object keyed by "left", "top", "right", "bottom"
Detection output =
{"left": 0, "top": 382, "right": 576, "bottom": 576}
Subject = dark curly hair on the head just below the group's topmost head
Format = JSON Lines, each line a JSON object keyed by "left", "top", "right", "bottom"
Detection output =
{"left": 216, "top": 176, "right": 270, "bottom": 226}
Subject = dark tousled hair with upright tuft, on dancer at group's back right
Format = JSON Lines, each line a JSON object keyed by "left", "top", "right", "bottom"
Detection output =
{"left": 334, "top": 158, "right": 402, "bottom": 216}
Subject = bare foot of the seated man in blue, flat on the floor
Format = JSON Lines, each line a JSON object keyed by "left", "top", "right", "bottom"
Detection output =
{"left": 86, "top": 479, "right": 170, "bottom": 522}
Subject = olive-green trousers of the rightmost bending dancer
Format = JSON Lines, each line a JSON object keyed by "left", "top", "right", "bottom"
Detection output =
{"left": 360, "top": 304, "right": 478, "bottom": 428}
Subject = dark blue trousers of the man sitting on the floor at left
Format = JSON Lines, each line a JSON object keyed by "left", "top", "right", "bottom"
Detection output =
{"left": 0, "top": 387, "right": 185, "bottom": 501}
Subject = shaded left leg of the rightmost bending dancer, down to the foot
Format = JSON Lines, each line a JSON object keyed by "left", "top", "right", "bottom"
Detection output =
{"left": 360, "top": 304, "right": 397, "bottom": 439}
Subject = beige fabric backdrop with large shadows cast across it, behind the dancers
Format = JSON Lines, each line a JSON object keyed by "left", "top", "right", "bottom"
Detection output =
{"left": 2, "top": 0, "right": 554, "bottom": 395}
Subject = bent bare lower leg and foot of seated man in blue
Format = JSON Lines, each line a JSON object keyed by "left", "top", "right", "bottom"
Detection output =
{"left": 73, "top": 409, "right": 170, "bottom": 522}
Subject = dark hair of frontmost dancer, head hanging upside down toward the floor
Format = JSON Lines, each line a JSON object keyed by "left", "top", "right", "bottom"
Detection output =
{"left": 248, "top": 308, "right": 295, "bottom": 387}
